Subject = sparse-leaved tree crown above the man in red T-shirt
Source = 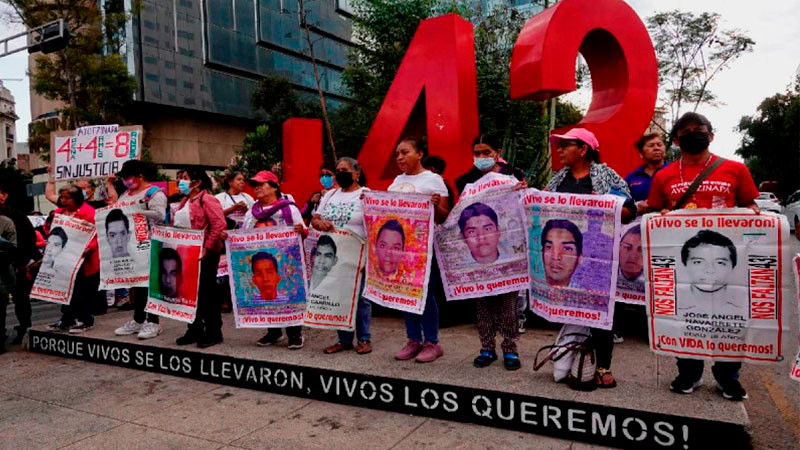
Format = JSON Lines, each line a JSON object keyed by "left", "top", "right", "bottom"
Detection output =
{"left": 647, "top": 10, "right": 755, "bottom": 131}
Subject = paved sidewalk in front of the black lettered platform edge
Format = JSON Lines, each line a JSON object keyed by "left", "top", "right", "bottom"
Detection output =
{"left": 0, "top": 351, "right": 602, "bottom": 450}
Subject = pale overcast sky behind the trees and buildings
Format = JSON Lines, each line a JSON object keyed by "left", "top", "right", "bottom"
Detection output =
{"left": 0, "top": 0, "right": 800, "bottom": 161}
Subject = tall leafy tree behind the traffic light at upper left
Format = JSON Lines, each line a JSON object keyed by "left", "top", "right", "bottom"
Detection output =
{"left": 3, "top": 0, "right": 136, "bottom": 129}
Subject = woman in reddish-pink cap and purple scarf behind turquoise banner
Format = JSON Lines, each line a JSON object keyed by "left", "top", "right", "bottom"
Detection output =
{"left": 242, "top": 170, "right": 307, "bottom": 350}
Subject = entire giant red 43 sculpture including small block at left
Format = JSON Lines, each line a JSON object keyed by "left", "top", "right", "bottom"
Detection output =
{"left": 283, "top": 0, "right": 658, "bottom": 200}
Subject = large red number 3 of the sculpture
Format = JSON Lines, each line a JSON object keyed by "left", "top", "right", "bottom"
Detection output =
{"left": 510, "top": 0, "right": 658, "bottom": 176}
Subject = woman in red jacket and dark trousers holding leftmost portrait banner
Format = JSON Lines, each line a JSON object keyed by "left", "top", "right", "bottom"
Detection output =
{"left": 48, "top": 184, "right": 100, "bottom": 334}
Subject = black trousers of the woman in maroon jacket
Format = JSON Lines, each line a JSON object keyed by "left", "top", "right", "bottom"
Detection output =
{"left": 189, "top": 253, "right": 222, "bottom": 336}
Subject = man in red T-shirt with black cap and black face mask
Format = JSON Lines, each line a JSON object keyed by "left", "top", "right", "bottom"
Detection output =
{"left": 647, "top": 112, "right": 760, "bottom": 401}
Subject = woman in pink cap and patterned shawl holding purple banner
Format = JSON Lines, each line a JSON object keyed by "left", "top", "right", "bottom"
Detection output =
{"left": 547, "top": 128, "right": 636, "bottom": 388}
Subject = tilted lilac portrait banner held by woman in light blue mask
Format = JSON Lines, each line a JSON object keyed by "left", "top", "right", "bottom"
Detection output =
{"left": 434, "top": 172, "right": 529, "bottom": 300}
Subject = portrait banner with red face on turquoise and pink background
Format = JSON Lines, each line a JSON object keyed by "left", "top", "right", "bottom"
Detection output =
{"left": 225, "top": 227, "right": 308, "bottom": 328}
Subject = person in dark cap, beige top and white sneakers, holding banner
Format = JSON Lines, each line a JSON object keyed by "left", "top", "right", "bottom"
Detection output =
{"left": 114, "top": 159, "right": 167, "bottom": 339}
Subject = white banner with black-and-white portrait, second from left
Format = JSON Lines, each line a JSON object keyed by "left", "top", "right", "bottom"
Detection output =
{"left": 95, "top": 204, "right": 150, "bottom": 289}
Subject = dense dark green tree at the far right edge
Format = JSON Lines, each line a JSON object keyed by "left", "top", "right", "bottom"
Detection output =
{"left": 736, "top": 79, "right": 800, "bottom": 198}
